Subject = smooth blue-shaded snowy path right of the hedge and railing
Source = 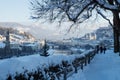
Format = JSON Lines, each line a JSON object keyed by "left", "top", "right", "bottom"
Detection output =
{"left": 68, "top": 50, "right": 120, "bottom": 80}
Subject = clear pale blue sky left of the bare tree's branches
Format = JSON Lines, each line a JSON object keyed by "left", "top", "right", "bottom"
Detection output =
{"left": 0, "top": 0, "right": 31, "bottom": 22}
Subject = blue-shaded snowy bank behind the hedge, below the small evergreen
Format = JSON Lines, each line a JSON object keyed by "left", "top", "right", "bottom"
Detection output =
{"left": 0, "top": 50, "right": 92, "bottom": 80}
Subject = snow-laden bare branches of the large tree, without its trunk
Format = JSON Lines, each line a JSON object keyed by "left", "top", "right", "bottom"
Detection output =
{"left": 31, "top": 0, "right": 120, "bottom": 23}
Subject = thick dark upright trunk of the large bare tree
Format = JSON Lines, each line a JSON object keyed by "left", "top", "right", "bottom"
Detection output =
{"left": 113, "top": 11, "right": 120, "bottom": 53}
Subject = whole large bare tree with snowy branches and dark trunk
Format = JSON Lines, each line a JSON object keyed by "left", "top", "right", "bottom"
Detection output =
{"left": 30, "top": 0, "right": 120, "bottom": 52}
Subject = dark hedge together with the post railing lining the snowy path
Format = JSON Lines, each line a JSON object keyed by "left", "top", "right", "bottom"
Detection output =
{"left": 7, "top": 50, "right": 97, "bottom": 80}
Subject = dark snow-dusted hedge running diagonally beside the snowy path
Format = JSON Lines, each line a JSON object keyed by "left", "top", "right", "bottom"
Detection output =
{"left": 6, "top": 50, "right": 94, "bottom": 80}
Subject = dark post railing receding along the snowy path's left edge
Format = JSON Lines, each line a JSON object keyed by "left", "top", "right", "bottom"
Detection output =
{"left": 47, "top": 50, "right": 96, "bottom": 80}
